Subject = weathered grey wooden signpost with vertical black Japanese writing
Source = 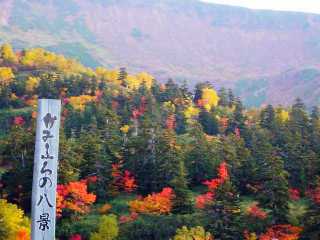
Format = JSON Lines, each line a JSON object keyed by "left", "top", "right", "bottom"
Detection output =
{"left": 31, "top": 99, "right": 61, "bottom": 240}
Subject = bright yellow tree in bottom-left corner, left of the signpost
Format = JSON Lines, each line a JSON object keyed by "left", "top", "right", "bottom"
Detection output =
{"left": 0, "top": 199, "right": 30, "bottom": 240}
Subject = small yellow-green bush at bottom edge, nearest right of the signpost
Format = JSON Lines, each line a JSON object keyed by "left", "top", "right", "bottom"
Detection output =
{"left": 90, "top": 214, "right": 119, "bottom": 240}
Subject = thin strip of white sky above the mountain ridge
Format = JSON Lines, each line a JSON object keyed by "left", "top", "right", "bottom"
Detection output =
{"left": 202, "top": 0, "right": 320, "bottom": 14}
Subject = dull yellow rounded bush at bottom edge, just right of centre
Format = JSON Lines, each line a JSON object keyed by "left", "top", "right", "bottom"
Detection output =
{"left": 173, "top": 226, "right": 213, "bottom": 240}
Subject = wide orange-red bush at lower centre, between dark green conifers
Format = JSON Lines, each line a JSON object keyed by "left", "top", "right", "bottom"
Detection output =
{"left": 129, "top": 187, "right": 175, "bottom": 215}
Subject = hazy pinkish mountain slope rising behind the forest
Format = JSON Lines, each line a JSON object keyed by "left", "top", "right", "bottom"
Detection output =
{"left": 0, "top": 0, "right": 320, "bottom": 105}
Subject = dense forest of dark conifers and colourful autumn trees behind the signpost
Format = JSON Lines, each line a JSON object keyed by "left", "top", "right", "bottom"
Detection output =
{"left": 0, "top": 44, "right": 320, "bottom": 240}
